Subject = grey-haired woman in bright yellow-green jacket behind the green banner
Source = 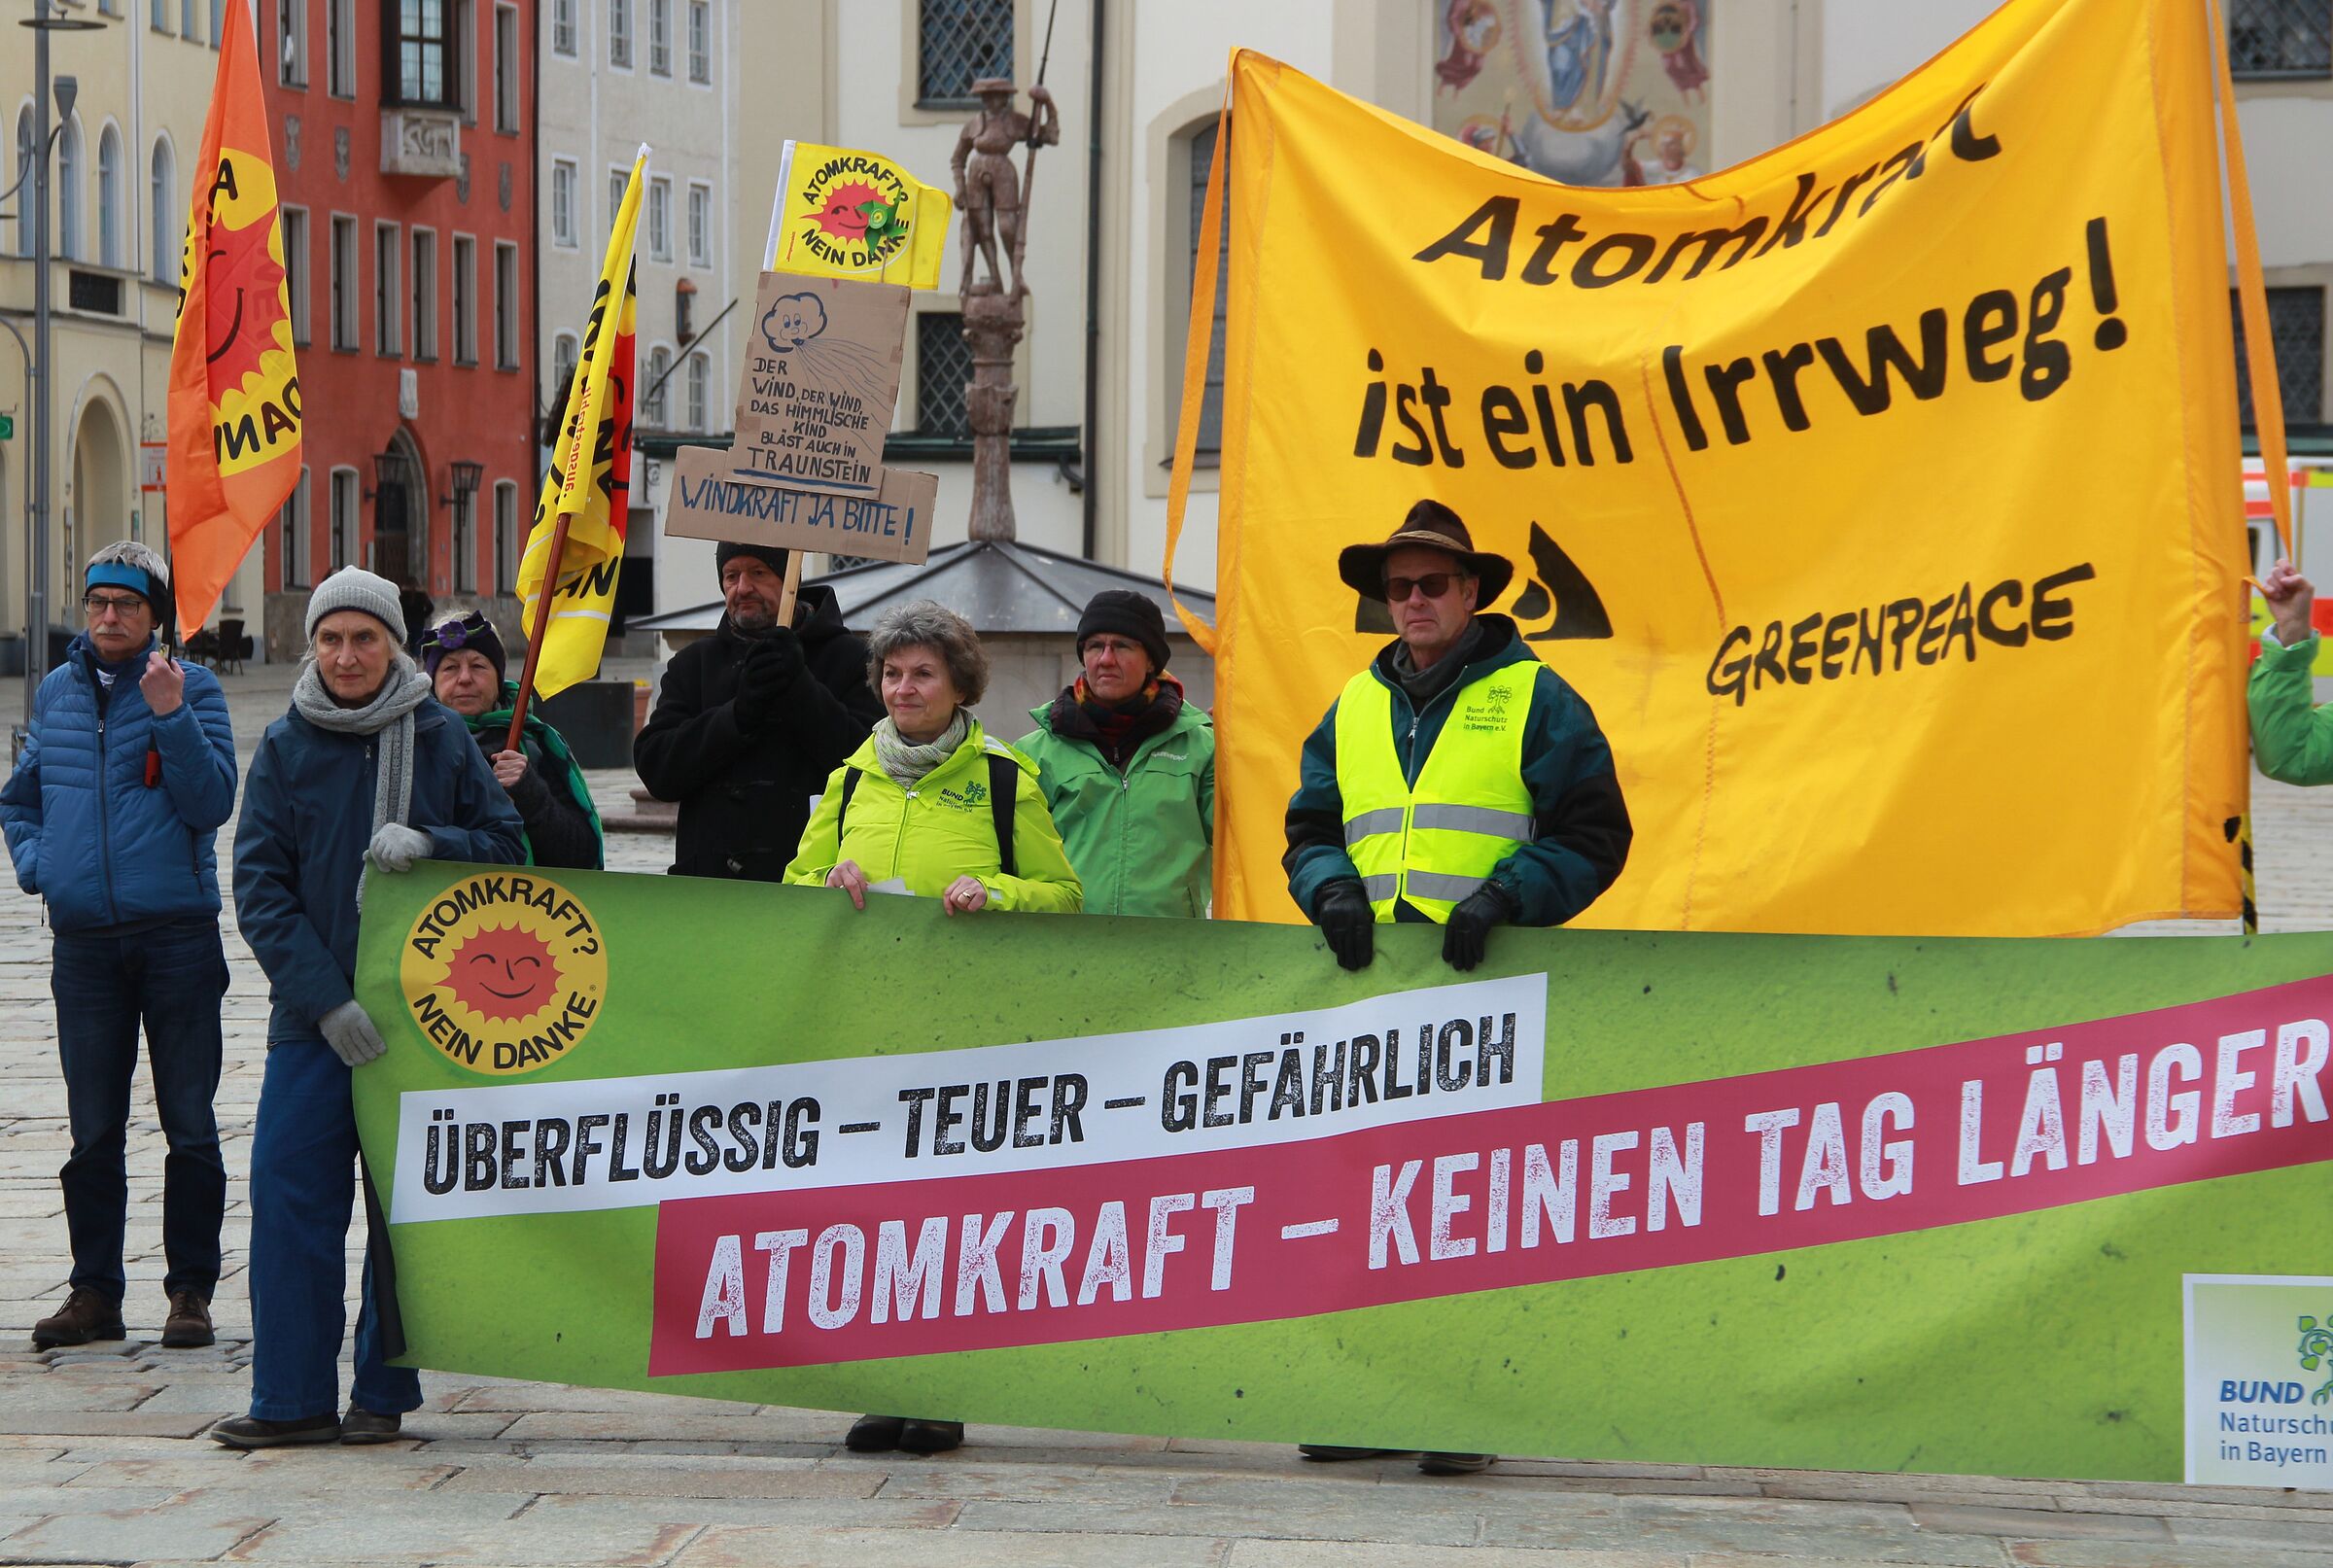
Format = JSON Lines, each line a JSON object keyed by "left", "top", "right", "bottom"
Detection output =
{"left": 786, "top": 600, "right": 1085, "bottom": 1453}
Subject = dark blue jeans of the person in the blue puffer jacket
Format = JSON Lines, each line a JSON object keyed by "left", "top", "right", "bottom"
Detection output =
{"left": 49, "top": 920, "right": 226, "bottom": 1307}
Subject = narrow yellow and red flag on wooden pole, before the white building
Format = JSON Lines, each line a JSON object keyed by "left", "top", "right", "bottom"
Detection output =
{"left": 518, "top": 147, "right": 648, "bottom": 698}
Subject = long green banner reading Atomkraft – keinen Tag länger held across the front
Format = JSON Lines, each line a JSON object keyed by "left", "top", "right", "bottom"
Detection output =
{"left": 355, "top": 866, "right": 2333, "bottom": 1486}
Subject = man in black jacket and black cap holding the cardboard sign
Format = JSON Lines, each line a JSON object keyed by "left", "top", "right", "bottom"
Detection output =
{"left": 632, "top": 541, "right": 882, "bottom": 882}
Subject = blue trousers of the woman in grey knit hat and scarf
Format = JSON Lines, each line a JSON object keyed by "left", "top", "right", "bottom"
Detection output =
{"left": 252, "top": 1041, "right": 422, "bottom": 1421}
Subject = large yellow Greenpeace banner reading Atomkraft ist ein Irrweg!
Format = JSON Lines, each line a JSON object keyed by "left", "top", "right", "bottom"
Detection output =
{"left": 1168, "top": 0, "right": 2246, "bottom": 936}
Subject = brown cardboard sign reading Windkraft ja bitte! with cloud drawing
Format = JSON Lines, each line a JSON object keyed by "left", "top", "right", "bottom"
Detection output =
{"left": 665, "top": 273, "right": 940, "bottom": 560}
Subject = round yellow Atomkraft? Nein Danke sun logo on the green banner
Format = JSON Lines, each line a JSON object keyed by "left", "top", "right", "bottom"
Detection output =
{"left": 399, "top": 870, "right": 607, "bottom": 1078}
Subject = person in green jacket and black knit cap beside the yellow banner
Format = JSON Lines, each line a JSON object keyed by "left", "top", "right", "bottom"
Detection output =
{"left": 1015, "top": 588, "right": 1215, "bottom": 917}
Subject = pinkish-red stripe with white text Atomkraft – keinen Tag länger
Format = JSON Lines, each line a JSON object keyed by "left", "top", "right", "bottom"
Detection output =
{"left": 648, "top": 978, "right": 2333, "bottom": 1376}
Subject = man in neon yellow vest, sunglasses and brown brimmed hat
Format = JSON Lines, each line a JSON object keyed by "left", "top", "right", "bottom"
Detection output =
{"left": 1283, "top": 502, "right": 1631, "bottom": 971}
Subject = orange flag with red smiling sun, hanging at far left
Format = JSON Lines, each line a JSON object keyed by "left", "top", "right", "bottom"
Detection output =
{"left": 168, "top": 5, "right": 301, "bottom": 635}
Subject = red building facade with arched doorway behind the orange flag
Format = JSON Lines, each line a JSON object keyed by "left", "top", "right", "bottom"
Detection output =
{"left": 259, "top": 0, "right": 537, "bottom": 658}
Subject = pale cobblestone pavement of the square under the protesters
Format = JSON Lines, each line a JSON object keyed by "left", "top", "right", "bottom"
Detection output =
{"left": 0, "top": 653, "right": 2333, "bottom": 1568}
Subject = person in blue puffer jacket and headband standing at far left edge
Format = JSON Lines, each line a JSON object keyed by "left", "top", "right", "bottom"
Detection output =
{"left": 0, "top": 541, "right": 235, "bottom": 1348}
